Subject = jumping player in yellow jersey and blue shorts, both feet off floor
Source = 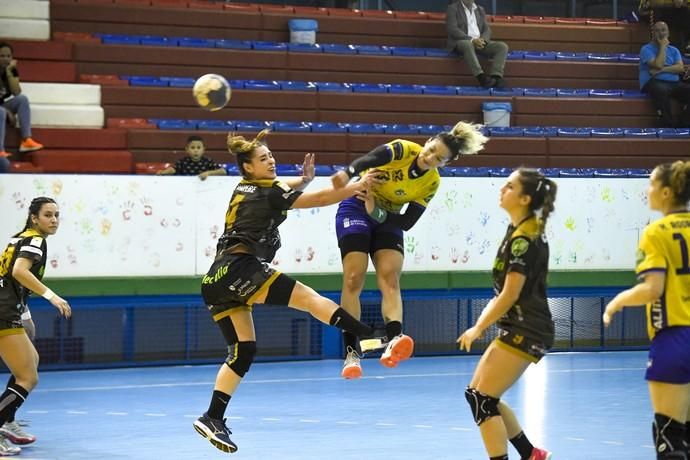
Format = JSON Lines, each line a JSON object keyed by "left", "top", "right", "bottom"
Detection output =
{"left": 333, "top": 122, "right": 488, "bottom": 379}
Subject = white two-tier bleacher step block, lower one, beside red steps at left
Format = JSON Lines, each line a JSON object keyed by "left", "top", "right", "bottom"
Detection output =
{"left": 22, "top": 83, "right": 105, "bottom": 128}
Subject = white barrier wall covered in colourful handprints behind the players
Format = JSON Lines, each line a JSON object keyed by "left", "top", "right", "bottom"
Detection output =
{"left": 0, "top": 174, "right": 659, "bottom": 277}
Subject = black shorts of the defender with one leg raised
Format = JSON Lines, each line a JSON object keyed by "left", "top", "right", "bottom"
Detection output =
{"left": 201, "top": 254, "right": 296, "bottom": 321}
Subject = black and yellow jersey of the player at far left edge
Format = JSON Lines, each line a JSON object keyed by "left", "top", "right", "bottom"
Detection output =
{"left": 0, "top": 230, "right": 48, "bottom": 308}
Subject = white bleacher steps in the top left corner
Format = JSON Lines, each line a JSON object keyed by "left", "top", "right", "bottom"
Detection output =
{"left": 0, "top": 0, "right": 50, "bottom": 40}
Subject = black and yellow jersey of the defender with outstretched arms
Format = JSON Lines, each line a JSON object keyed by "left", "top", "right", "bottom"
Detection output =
{"left": 217, "top": 180, "right": 302, "bottom": 262}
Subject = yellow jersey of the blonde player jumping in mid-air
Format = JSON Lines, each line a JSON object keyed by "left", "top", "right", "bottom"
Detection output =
{"left": 360, "top": 139, "right": 441, "bottom": 213}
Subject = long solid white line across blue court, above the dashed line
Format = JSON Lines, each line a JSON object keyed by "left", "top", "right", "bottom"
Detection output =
{"left": 33, "top": 367, "right": 646, "bottom": 393}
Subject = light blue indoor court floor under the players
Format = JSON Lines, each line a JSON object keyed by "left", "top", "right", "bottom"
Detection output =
{"left": 9, "top": 352, "right": 654, "bottom": 460}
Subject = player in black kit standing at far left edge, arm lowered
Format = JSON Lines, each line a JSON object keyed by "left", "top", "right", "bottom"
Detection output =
{"left": 0, "top": 197, "right": 72, "bottom": 456}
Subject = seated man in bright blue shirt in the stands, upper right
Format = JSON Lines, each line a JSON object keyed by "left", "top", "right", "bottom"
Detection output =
{"left": 640, "top": 22, "right": 690, "bottom": 127}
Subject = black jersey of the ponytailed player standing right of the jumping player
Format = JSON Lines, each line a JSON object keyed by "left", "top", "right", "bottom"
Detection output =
{"left": 493, "top": 216, "right": 554, "bottom": 347}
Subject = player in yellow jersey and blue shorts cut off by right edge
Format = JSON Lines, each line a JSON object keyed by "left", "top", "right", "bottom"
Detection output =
{"left": 604, "top": 161, "right": 690, "bottom": 460}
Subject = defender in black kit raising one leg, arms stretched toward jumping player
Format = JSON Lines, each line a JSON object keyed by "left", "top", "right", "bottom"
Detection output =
{"left": 194, "top": 130, "right": 375, "bottom": 452}
